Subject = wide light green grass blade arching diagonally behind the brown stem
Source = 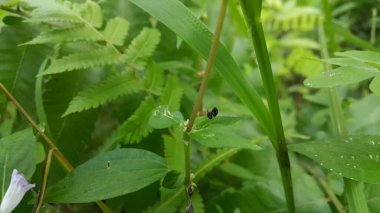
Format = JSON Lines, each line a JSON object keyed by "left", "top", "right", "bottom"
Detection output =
{"left": 130, "top": 0, "right": 275, "bottom": 140}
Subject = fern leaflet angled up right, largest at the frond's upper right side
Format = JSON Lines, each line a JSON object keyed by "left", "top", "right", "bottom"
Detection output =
{"left": 125, "top": 28, "right": 161, "bottom": 69}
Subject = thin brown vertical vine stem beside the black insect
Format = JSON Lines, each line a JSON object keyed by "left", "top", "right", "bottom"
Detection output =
{"left": 184, "top": 0, "right": 228, "bottom": 204}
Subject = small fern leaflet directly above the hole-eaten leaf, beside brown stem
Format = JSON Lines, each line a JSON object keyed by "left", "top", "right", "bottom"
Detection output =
{"left": 159, "top": 76, "right": 183, "bottom": 111}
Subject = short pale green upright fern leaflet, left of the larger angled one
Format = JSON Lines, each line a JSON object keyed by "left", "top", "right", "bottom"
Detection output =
{"left": 103, "top": 18, "right": 129, "bottom": 46}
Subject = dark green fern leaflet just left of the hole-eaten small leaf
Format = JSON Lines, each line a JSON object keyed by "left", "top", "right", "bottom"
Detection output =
{"left": 118, "top": 97, "right": 155, "bottom": 143}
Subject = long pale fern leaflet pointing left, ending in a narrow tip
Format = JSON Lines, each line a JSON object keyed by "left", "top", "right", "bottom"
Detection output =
{"left": 43, "top": 48, "right": 121, "bottom": 75}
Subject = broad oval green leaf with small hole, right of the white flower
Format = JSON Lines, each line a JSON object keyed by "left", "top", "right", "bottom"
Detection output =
{"left": 46, "top": 149, "right": 168, "bottom": 203}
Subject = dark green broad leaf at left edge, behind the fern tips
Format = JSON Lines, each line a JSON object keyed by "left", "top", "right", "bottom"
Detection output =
{"left": 0, "top": 24, "right": 50, "bottom": 116}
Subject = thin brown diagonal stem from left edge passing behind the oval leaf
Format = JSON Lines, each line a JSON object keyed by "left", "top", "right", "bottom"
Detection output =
{"left": 0, "top": 83, "right": 111, "bottom": 213}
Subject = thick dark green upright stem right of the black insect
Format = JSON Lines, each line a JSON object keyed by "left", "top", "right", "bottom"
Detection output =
{"left": 240, "top": 0, "right": 295, "bottom": 212}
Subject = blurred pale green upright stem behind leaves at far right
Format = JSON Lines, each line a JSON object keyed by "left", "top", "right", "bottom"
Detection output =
{"left": 318, "top": 0, "right": 369, "bottom": 213}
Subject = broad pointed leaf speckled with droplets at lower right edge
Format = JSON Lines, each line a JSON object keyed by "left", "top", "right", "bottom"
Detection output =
{"left": 289, "top": 135, "right": 380, "bottom": 183}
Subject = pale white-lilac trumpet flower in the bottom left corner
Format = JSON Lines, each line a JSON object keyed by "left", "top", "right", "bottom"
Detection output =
{"left": 0, "top": 169, "right": 35, "bottom": 213}
